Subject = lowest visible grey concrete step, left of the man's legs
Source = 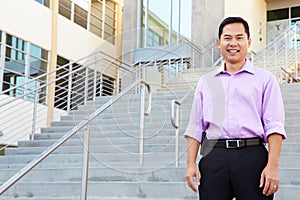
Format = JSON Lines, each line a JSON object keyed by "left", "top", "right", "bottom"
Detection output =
{"left": 2, "top": 181, "right": 197, "bottom": 199}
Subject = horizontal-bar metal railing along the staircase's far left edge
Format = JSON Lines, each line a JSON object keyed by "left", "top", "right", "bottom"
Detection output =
{"left": 0, "top": 51, "right": 136, "bottom": 150}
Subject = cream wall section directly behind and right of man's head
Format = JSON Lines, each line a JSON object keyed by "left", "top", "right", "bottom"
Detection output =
{"left": 224, "top": 0, "right": 267, "bottom": 52}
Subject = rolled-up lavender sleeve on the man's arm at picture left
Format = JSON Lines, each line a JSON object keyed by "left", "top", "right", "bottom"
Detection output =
{"left": 184, "top": 80, "right": 203, "bottom": 142}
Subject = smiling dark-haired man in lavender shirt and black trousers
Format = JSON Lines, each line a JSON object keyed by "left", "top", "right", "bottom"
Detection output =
{"left": 185, "top": 17, "right": 286, "bottom": 200}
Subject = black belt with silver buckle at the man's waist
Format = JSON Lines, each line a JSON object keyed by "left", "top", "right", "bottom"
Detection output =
{"left": 212, "top": 138, "right": 264, "bottom": 149}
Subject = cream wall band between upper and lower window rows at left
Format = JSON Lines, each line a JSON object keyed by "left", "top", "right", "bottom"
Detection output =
{"left": 0, "top": 0, "right": 116, "bottom": 65}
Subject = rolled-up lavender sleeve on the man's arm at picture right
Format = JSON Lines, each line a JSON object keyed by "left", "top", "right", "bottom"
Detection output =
{"left": 262, "top": 76, "right": 286, "bottom": 139}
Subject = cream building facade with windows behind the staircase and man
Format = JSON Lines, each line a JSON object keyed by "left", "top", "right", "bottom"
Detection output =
{"left": 0, "top": 0, "right": 300, "bottom": 144}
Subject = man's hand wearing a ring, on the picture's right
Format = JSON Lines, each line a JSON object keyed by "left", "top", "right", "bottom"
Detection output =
{"left": 259, "top": 165, "right": 279, "bottom": 196}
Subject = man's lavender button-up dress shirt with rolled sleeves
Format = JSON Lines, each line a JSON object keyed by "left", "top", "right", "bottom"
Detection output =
{"left": 184, "top": 61, "right": 286, "bottom": 142}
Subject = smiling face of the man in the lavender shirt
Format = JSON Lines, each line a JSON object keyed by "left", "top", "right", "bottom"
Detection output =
{"left": 217, "top": 23, "right": 251, "bottom": 66}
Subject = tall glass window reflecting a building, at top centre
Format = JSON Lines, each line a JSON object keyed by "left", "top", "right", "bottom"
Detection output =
{"left": 141, "top": 0, "right": 192, "bottom": 47}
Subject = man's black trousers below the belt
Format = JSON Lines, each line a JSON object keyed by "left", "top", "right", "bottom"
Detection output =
{"left": 199, "top": 145, "right": 273, "bottom": 200}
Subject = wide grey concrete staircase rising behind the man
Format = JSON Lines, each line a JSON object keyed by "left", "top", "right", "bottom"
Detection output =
{"left": 0, "top": 72, "right": 300, "bottom": 200}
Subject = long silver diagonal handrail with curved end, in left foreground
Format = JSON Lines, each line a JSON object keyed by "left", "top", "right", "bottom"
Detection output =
{"left": 0, "top": 79, "right": 152, "bottom": 195}
